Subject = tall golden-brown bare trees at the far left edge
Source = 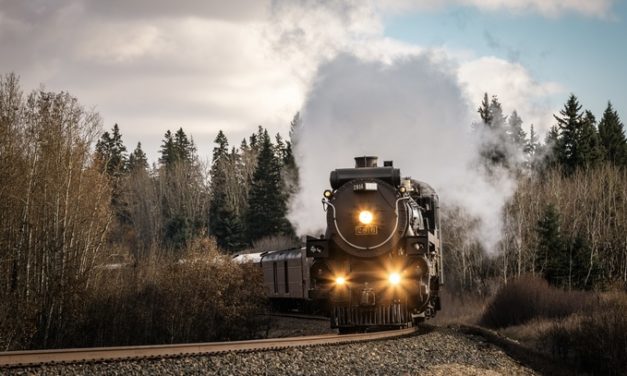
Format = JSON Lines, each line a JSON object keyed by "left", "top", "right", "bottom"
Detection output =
{"left": 0, "top": 75, "right": 111, "bottom": 348}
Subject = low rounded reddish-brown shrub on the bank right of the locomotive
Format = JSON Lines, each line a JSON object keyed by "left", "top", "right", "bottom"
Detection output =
{"left": 479, "top": 276, "right": 591, "bottom": 328}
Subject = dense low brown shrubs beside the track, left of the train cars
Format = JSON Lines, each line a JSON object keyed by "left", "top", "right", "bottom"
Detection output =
{"left": 62, "top": 238, "right": 266, "bottom": 347}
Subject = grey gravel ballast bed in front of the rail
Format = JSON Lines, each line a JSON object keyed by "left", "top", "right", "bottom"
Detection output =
{"left": 0, "top": 328, "right": 537, "bottom": 376}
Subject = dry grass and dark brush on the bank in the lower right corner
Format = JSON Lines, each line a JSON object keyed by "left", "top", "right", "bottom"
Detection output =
{"left": 480, "top": 278, "right": 627, "bottom": 375}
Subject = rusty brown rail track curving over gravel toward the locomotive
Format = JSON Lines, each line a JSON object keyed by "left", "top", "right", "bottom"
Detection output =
{"left": 0, "top": 327, "right": 418, "bottom": 369}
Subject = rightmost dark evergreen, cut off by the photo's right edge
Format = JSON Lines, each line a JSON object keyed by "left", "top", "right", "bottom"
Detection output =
{"left": 599, "top": 102, "right": 627, "bottom": 166}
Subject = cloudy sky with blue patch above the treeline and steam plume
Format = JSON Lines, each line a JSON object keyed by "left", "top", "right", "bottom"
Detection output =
{"left": 0, "top": 0, "right": 627, "bottom": 165}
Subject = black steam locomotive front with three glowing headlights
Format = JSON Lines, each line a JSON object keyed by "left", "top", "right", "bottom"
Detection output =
{"left": 306, "top": 156, "right": 443, "bottom": 332}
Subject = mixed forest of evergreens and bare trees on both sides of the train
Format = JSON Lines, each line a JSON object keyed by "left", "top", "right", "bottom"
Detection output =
{"left": 0, "top": 74, "right": 627, "bottom": 356}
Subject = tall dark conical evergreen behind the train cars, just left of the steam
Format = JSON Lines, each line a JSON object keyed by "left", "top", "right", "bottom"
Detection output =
{"left": 246, "top": 130, "right": 294, "bottom": 242}
